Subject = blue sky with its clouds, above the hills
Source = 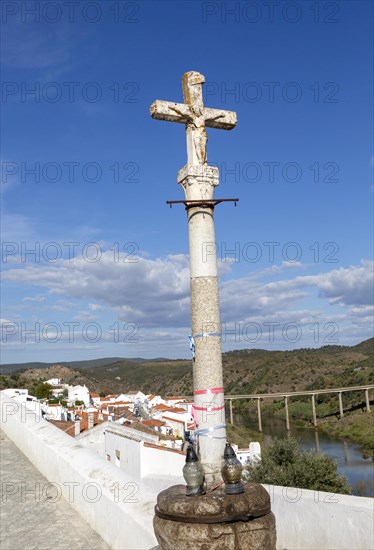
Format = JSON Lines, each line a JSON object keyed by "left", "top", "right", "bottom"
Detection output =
{"left": 1, "top": 0, "right": 373, "bottom": 363}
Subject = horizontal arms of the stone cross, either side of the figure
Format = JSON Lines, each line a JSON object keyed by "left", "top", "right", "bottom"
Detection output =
{"left": 150, "top": 99, "right": 237, "bottom": 130}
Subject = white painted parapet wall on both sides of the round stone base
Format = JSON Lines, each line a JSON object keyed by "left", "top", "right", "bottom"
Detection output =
{"left": 0, "top": 392, "right": 374, "bottom": 550}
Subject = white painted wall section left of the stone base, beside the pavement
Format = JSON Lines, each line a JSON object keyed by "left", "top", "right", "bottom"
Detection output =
{"left": 0, "top": 394, "right": 157, "bottom": 550}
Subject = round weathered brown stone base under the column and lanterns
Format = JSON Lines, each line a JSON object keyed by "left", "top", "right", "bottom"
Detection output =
{"left": 153, "top": 483, "right": 276, "bottom": 550}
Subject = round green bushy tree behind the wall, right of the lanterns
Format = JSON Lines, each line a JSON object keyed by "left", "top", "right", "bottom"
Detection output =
{"left": 247, "top": 437, "right": 351, "bottom": 494}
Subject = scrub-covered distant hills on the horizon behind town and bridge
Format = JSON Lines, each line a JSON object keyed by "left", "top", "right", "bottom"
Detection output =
{"left": 0, "top": 338, "right": 374, "bottom": 402}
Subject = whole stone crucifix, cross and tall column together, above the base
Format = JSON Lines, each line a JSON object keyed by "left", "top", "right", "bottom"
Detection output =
{"left": 150, "top": 71, "right": 237, "bottom": 490}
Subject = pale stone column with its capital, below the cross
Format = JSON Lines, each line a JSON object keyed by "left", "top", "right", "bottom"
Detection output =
{"left": 178, "top": 164, "right": 226, "bottom": 489}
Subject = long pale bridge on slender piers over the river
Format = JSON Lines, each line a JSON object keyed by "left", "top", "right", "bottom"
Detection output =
{"left": 225, "top": 385, "right": 374, "bottom": 432}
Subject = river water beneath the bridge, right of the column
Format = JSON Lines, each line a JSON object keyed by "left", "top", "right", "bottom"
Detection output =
{"left": 235, "top": 414, "right": 374, "bottom": 497}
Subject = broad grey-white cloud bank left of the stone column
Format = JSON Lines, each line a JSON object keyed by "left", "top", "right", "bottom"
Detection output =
{"left": 3, "top": 252, "right": 189, "bottom": 326}
